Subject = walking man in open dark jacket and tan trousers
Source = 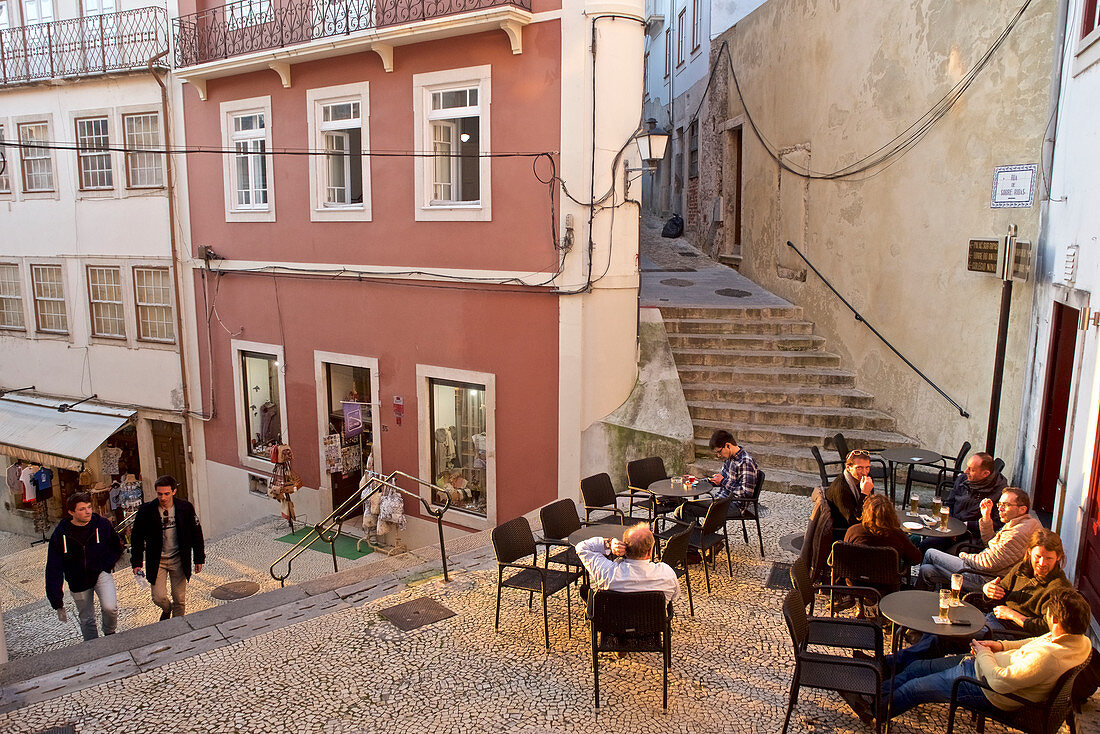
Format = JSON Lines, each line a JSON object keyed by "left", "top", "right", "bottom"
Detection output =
{"left": 130, "top": 474, "right": 206, "bottom": 620}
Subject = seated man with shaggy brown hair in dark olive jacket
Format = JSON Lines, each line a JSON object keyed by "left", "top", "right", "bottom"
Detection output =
{"left": 886, "top": 527, "right": 1070, "bottom": 670}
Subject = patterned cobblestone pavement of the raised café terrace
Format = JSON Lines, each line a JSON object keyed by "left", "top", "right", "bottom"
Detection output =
{"left": 0, "top": 492, "right": 1100, "bottom": 734}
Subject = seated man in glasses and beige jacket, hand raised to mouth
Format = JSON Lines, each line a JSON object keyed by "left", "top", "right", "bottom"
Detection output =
{"left": 920, "top": 486, "right": 1042, "bottom": 593}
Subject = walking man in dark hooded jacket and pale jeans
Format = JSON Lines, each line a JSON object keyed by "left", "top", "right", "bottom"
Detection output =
{"left": 46, "top": 492, "right": 122, "bottom": 639}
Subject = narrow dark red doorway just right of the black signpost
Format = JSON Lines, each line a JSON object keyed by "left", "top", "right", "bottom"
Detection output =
{"left": 1032, "top": 303, "right": 1079, "bottom": 514}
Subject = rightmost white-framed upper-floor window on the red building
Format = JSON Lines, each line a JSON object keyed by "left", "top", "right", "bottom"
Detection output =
{"left": 413, "top": 66, "right": 492, "bottom": 221}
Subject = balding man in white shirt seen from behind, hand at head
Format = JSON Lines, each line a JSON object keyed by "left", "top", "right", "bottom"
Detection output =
{"left": 576, "top": 523, "right": 680, "bottom": 603}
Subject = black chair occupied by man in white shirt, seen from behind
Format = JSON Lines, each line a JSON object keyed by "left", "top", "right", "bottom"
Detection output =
{"left": 589, "top": 590, "right": 672, "bottom": 709}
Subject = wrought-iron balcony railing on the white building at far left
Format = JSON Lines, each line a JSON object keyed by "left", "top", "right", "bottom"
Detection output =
{"left": 0, "top": 8, "right": 168, "bottom": 84}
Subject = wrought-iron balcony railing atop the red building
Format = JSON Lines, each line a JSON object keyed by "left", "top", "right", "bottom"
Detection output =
{"left": 174, "top": 0, "right": 531, "bottom": 66}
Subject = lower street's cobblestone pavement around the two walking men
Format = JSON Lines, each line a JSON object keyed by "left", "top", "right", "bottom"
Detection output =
{"left": 0, "top": 517, "right": 385, "bottom": 659}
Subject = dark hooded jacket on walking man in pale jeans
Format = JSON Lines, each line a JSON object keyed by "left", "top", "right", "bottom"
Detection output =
{"left": 46, "top": 513, "right": 122, "bottom": 610}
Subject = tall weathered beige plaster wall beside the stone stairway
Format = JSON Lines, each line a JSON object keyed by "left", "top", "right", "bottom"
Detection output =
{"left": 701, "top": 0, "right": 1056, "bottom": 468}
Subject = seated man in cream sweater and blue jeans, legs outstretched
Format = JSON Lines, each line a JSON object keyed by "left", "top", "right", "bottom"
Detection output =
{"left": 875, "top": 589, "right": 1092, "bottom": 717}
